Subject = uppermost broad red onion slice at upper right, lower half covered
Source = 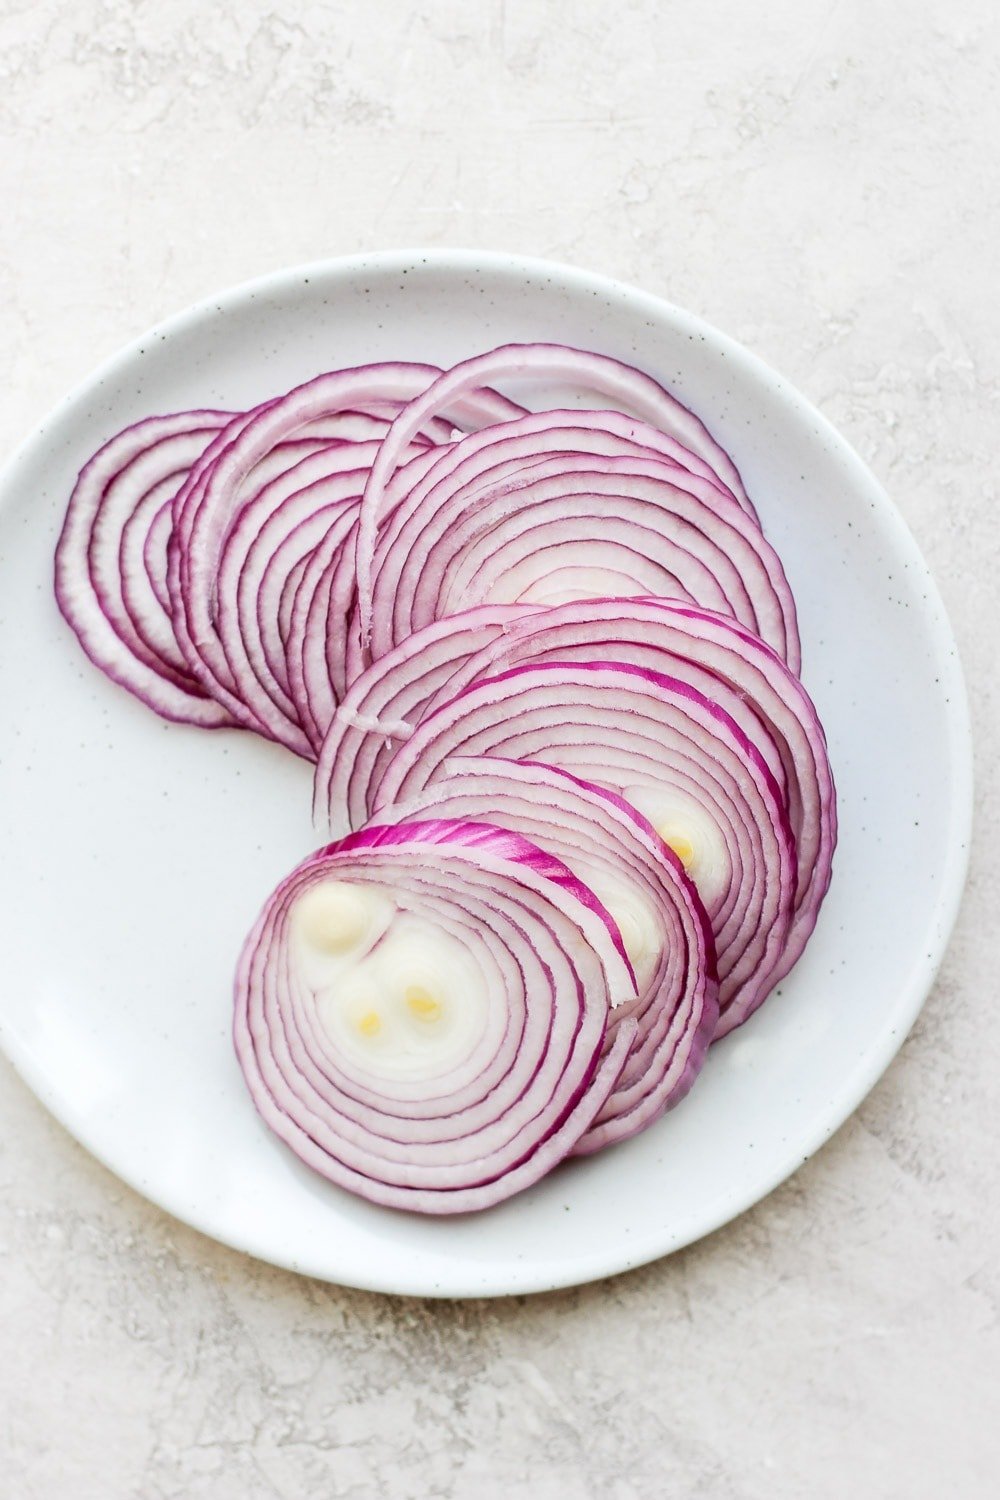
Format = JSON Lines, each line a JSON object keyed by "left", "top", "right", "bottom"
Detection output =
{"left": 370, "top": 443, "right": 799, "bottom": 671}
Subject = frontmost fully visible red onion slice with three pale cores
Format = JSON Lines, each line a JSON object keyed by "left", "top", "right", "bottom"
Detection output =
{"left": 234, "top": 821, "right": 634, "bottom": 1214}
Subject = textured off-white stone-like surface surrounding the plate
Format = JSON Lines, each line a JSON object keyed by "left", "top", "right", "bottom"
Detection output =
{"left": 0, "top": 0, "right": 1000, "bottom": 1500}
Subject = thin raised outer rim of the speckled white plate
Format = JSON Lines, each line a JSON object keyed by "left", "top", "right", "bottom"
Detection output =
{"left": 0, "top": 246, "right": 975, "bottom": 1299}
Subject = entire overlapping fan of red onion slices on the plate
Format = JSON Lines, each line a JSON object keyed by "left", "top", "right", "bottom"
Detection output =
{"left": 55, "top": 345, "right": 837, "bottom": 1214}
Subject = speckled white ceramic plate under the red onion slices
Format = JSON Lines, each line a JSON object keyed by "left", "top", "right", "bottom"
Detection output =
{"left": 0, "top": 251, "right": 972, "bottom": 1296}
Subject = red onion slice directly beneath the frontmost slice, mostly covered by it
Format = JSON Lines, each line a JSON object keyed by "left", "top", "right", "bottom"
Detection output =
{"left": 374, "top": 758, "right": 718, "bottom": 1155}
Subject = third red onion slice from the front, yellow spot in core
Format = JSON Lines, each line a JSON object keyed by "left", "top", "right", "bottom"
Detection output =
{"left": 375, "top": 662, "right": 796, "bottom": 1031}
